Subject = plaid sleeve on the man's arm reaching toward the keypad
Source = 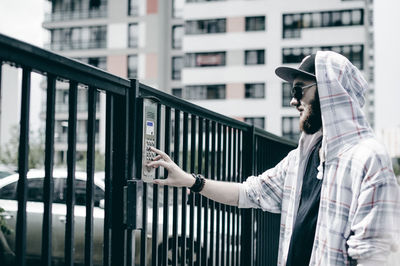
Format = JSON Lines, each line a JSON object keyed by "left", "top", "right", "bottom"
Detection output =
{"left": 239, "top": 151, "right": 294, "bottom": 213}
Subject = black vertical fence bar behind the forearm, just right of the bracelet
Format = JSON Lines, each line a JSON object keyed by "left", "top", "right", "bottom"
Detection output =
{"left": 210, "top": 121, "right": 218, "bottom": 265}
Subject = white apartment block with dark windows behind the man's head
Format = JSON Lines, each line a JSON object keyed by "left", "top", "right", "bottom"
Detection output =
{"left": 178, "top": 0, "right": 373, "bottom": 139}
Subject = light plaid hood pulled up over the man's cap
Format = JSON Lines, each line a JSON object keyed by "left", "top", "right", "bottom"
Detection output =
{"left": 315, "top": 51, "right": 374, "bottom": 162}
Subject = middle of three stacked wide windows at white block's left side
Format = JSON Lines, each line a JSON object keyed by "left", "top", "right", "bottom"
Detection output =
{"left": 185, "top": 52, "right": 225, "bottom": 67}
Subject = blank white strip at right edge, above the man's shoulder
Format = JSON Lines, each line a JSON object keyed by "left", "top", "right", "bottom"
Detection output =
{"left": 374, "top": 0, "right": 400, "bottom": 157}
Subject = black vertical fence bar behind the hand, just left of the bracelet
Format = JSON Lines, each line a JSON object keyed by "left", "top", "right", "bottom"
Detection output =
{"left": 181, "top": 113, "right": 189, "bottom": 265}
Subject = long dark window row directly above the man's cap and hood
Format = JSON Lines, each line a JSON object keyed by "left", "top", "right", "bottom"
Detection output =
{"left": 282, "top": 44, "right": 364, "bottom": 70}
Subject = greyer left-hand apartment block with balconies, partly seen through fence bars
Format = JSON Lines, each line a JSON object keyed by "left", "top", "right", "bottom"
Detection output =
{"left": 43, "top": 0, "right": 183, "bottom": 163}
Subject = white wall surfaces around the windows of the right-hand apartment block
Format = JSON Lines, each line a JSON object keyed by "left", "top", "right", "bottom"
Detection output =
{"left": 182, "top": 0, "right": 366, "bottom": 135}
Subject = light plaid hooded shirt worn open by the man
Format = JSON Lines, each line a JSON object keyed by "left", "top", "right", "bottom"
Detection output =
{"left": 239, "top": 52, "right": 400, "bottom": 266}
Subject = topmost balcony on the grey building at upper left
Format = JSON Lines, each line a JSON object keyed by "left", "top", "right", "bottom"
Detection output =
{"left": 44, "top": 6, "right": 107, "bottom": 22}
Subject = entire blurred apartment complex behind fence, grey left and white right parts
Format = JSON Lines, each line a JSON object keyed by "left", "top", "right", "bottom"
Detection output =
{"left": 43, "top": 0, "right": 373, "bottom": 161}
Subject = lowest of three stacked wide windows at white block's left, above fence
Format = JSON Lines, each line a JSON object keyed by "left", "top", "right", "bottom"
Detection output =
{"left": 185, "top": 84, "right": 226, "bottom": 100}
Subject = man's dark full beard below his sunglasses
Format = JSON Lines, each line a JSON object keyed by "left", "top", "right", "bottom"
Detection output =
{"left": 300, "top": 90, "right": 322, "bottom": 135}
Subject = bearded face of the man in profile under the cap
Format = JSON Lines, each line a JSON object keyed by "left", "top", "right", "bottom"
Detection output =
{"left": 290, "top": 77, "right": 322, "bottom": 134}
